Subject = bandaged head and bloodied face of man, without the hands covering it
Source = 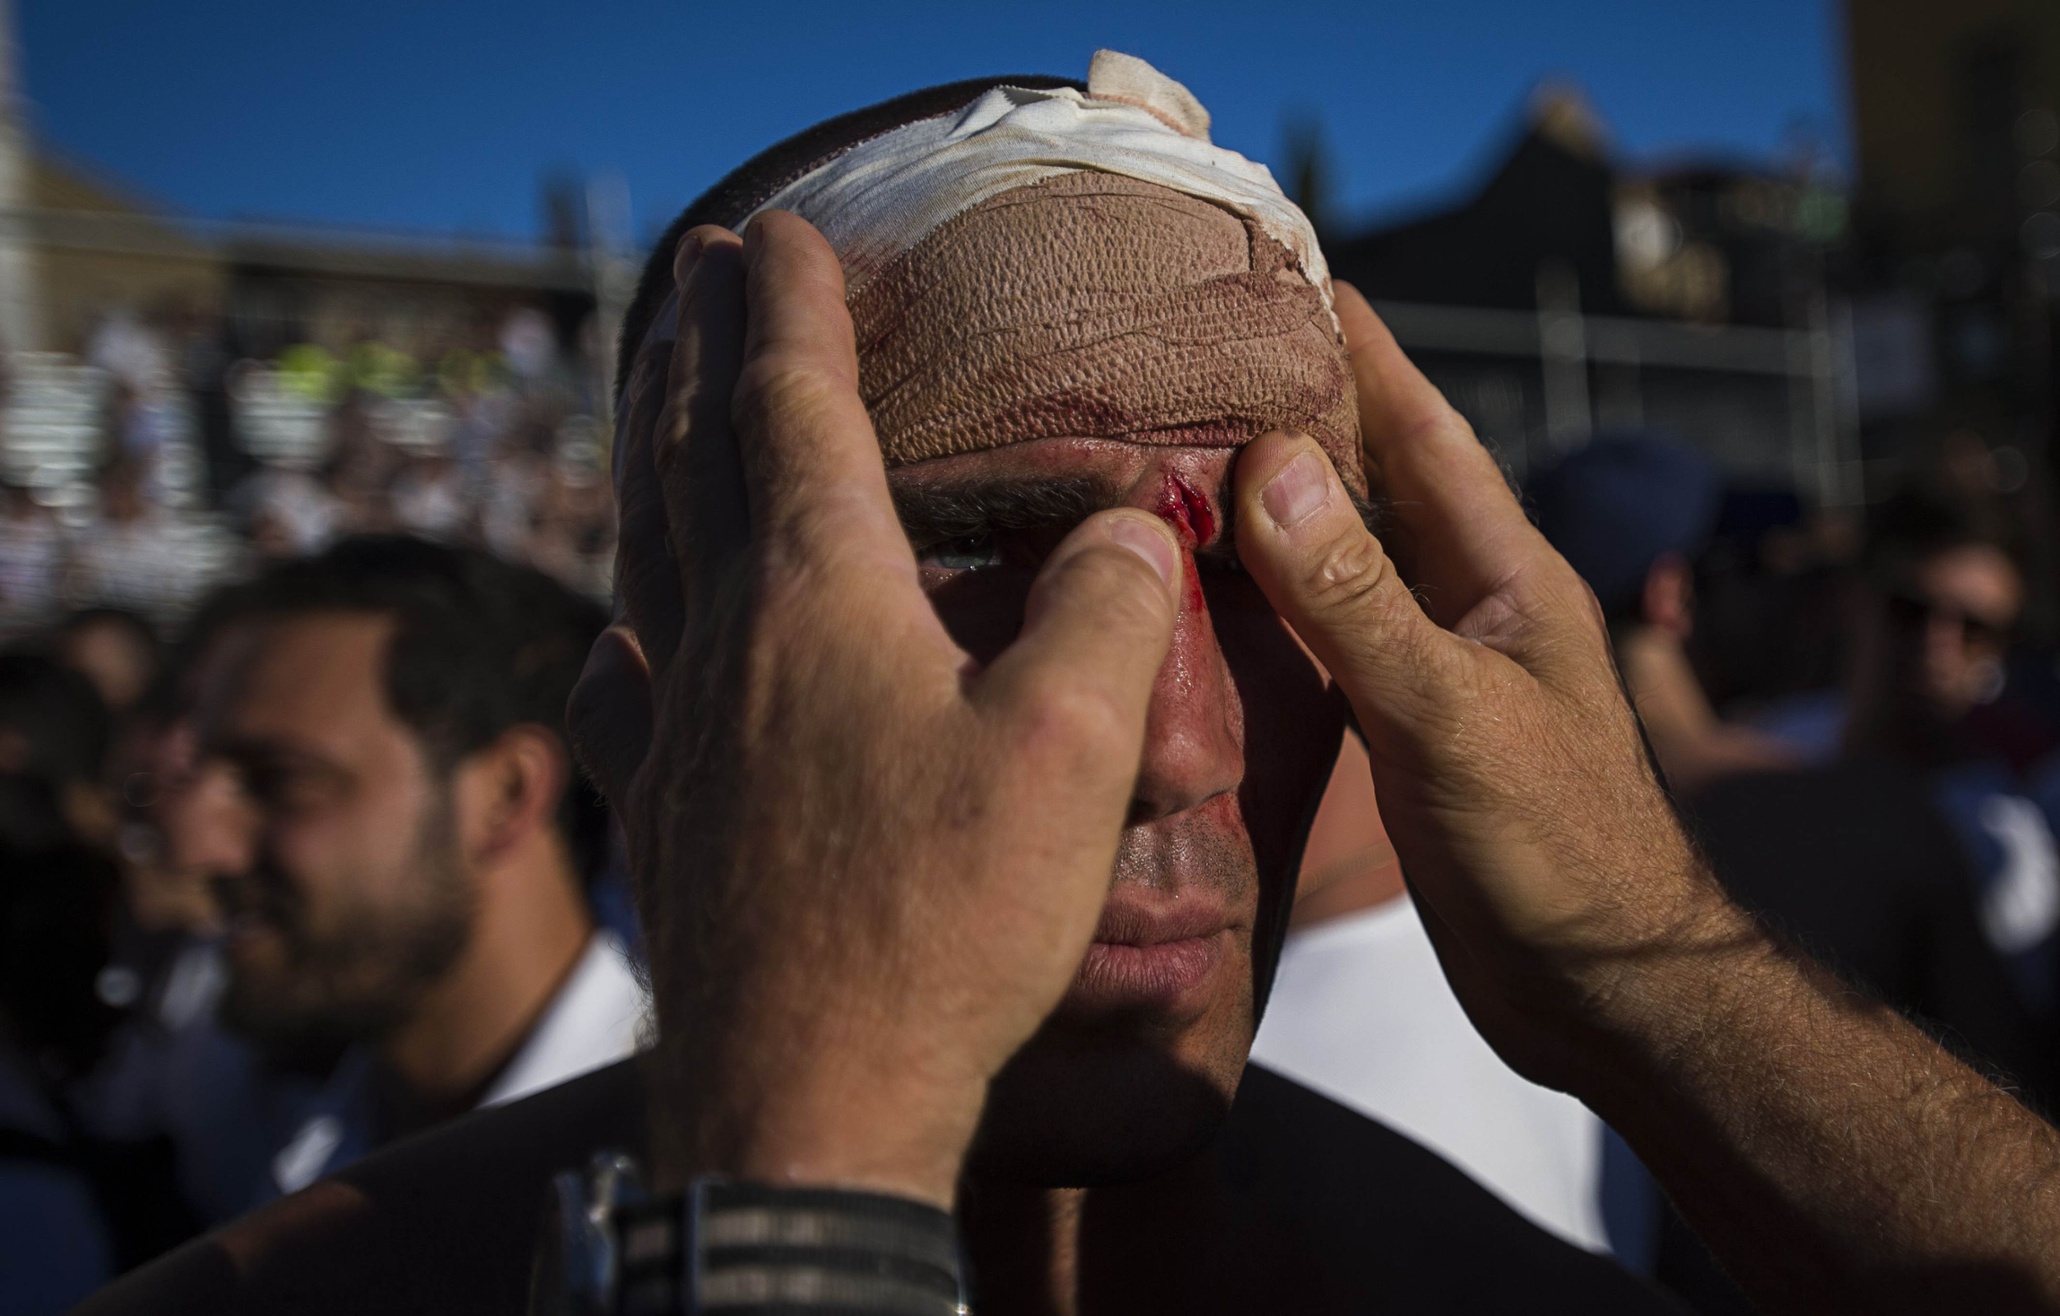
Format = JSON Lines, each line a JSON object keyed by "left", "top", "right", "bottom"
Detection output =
{"left": 620, "top": 51, "right": 1384, "bottom": 1182}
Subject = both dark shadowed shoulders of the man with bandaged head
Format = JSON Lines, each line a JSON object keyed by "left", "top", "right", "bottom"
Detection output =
{"left": 78, "top": 1063, "right": 1675, "bottom": 1316}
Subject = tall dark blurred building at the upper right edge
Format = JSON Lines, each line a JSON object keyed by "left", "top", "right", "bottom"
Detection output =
{"left": 1846, "top": 0, "right": 2060, "bottom": 463}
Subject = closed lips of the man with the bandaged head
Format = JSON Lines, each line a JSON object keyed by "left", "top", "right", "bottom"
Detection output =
{"left": 1063, "top": 892, "right": 1232, "bottom": 1015}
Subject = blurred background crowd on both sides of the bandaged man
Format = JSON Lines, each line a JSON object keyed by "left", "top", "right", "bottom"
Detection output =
{"left": 0, "top": 313, "right": 2060, "bottom": 1312}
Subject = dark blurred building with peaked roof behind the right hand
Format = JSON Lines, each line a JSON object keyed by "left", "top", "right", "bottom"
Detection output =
{"left": 1292, "top": 86, "right": 1862, "bottom": 505}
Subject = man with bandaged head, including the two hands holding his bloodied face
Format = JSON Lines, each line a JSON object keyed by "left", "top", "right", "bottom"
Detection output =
{"left": 89, "top": 54, "right": 2060, "bottom": 1312}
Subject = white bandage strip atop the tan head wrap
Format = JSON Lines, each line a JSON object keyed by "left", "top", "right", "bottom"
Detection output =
{"left": 737, "top": 49, "right": 1331, "bottom": 307}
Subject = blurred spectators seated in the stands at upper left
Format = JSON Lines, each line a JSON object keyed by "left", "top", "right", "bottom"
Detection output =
{"left": 0, "top": 307, "right": 614, "bottom": 628}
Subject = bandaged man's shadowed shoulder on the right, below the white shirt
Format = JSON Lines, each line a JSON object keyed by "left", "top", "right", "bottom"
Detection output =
{"left": 1220, "top": 1065, "right": 1677, "bottom": 1316}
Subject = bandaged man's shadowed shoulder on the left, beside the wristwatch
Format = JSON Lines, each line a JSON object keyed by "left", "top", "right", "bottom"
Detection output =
{"left": 78, "top": 1063, "right": 645, "bottom": 1316}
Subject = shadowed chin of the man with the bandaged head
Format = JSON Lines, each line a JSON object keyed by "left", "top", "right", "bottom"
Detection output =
{"left": 966, "top": 1024, "right": 1250, "bottom": 1188}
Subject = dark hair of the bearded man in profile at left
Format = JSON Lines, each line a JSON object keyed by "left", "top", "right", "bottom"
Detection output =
{"left": 230, "top": 535, "right": 608, "bottom": 881}
